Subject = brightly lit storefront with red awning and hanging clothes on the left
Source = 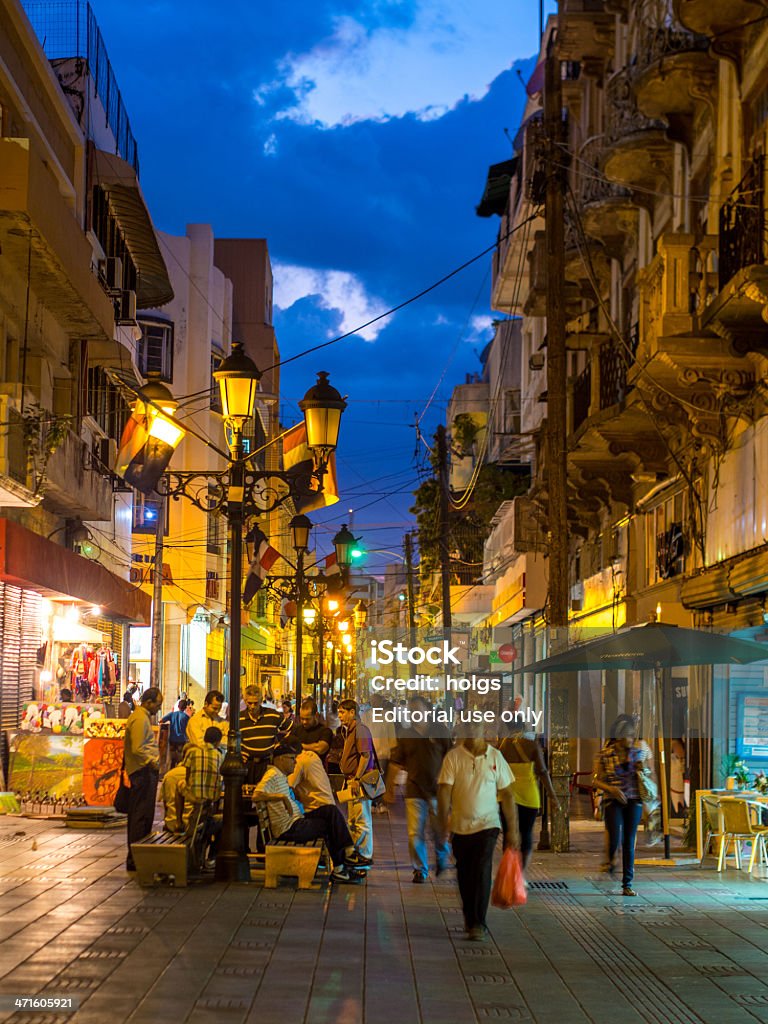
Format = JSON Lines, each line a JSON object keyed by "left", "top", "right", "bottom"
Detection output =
{"left": 0, "top": 519, "right": 150, "bottom": 800}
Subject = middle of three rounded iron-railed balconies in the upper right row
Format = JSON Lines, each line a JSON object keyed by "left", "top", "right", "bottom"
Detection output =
{"left": 600, "top": 68, "right": 674, "bottom": 190}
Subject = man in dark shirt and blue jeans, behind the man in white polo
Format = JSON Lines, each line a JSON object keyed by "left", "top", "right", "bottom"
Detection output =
{"left": 384, "top": 696, "right": 452, "bottom": 885}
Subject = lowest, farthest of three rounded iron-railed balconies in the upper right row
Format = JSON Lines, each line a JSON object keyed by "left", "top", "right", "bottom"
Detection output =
{"left": 574, "top": 137, "right": 639, "bottom": 258}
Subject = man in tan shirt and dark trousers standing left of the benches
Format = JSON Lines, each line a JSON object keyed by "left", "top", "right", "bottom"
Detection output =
{"left": 124, "top": 686, "right": 163, "bottom": 871}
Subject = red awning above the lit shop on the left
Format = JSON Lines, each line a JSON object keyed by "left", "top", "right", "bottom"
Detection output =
{"left": 0, "top": 519, "right": 152, "bottom": 624}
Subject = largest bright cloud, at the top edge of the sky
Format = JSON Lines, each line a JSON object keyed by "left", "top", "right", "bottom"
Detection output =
{"left": 254, "top": 0, "right": 532, "bottom": 128}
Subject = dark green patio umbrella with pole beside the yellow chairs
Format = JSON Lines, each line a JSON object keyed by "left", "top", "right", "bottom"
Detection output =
{"left": 522, "top": 623, "right": 768, "bottom": 860}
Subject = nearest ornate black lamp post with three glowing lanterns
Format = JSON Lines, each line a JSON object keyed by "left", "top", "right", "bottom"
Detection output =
{"left": 126, "top": 352, "right": 346, "bottom": 882}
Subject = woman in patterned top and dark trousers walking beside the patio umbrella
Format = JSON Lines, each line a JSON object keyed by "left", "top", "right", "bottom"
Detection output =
{"left": 593, "top": 715, "right": 650, "bottom": 896}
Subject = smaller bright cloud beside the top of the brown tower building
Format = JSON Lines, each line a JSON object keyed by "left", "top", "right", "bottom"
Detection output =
{"left": 273, "top": 263, "right": 389, "bottom": 341}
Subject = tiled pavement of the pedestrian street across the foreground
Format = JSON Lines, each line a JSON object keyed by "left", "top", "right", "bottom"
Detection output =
{"left": 0, "top": 812, "right": 768, "bottom": 1024}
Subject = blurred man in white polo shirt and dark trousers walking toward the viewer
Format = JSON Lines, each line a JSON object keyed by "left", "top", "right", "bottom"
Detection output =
{"left": 437, "top": 737, "right": 519, "bottom": 942}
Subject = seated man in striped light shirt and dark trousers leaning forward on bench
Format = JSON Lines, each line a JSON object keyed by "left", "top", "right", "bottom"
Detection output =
{"left": 253, "top": 743, "right": 370, "bottom": 882}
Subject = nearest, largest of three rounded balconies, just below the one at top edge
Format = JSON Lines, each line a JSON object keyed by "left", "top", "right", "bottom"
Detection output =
{"left": 634, "top": 18, "right": 717, "bottom": 146}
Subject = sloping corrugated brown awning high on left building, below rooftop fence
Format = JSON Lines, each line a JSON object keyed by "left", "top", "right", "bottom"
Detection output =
{"left": 93, "top": 150, "right": 173, "bottom": 309}
